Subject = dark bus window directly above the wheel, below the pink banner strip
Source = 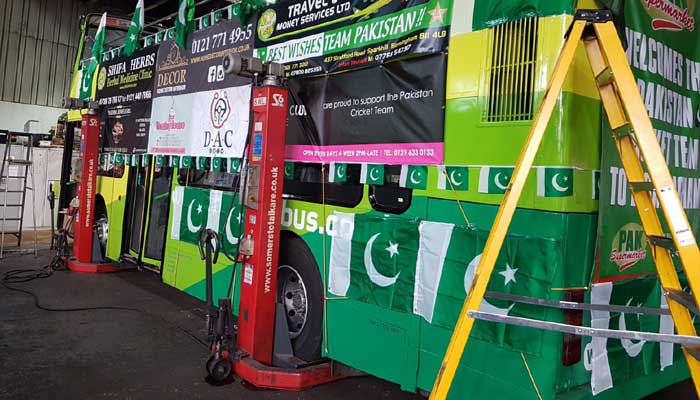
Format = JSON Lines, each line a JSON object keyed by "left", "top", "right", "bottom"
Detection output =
{"left": 284, "top": 163, "right": 362, "bottom": 207}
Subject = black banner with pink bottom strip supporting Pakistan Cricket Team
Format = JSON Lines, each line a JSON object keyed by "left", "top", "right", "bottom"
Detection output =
{"left": 286, "top": 54, "right": 447, "bottom": 164}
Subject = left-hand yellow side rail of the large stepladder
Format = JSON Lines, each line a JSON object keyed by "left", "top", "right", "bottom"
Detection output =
{"left": 430, "top": 21, "right": 586, "bottom": 399}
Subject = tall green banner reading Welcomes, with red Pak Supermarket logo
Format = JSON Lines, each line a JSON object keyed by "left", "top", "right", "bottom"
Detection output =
{"left": 595, "top": 0, "right": 700, "bottom": 282}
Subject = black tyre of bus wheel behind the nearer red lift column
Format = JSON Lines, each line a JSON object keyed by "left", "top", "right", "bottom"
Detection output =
{"left": 277, "top": 236, "right": 323, "bottom": 362}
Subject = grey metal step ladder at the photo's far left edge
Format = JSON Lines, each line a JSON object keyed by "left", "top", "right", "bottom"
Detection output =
{"left": 0, "top": 131, "right": 37, "bottom": 259}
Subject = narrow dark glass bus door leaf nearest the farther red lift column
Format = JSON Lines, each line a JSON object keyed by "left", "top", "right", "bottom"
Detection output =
{"left": 122, "top": 162, "right": 149, "bottom": 264}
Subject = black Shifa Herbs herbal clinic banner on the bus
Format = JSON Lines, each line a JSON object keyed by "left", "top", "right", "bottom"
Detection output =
{"left": 96, "top": 46, "right": 158, "bottom": 153}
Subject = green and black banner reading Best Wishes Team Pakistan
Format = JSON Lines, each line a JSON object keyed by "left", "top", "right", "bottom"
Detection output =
{"left": 255, "top": 0, "right": 452, "bottom": 77}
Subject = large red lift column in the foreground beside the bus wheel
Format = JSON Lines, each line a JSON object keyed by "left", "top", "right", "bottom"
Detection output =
{"left": 232, "top": 86, "right": 342, "bottom": 390}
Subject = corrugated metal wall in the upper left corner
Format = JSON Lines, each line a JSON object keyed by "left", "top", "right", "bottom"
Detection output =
{"left": 0, "top": 0, "right": 94, "bottom": 107}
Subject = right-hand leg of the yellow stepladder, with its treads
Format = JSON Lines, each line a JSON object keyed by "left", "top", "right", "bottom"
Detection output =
{"left": 586, "top": 22, "right": 700, "bottom": 393}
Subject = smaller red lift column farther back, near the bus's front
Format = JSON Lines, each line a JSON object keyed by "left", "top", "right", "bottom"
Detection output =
{"left": 68, "top": 109, "right": 117, "bottom": 273}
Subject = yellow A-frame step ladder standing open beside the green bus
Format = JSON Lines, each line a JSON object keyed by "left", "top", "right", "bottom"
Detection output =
{"left": 430, "top": 10, "right": 700, "bottom": 399}
